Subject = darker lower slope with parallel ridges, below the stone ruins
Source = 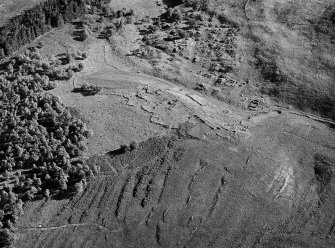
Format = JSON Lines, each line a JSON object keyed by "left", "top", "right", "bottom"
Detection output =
{"left": 17, "top": 114, "right": 335, "bottom": 247}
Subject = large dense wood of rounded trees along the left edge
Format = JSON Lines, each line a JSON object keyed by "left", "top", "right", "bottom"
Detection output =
{"left": 0, "top": 49, "right": 99, "bottom": 247}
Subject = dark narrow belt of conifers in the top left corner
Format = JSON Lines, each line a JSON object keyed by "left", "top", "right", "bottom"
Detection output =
{"left": 0, "top": 0, "right": 113, "bottom": 59}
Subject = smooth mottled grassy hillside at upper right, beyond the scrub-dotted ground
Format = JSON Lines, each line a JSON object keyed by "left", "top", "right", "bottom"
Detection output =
{"left": 246, "top": 1, "right": 335, "bottom": 119}
